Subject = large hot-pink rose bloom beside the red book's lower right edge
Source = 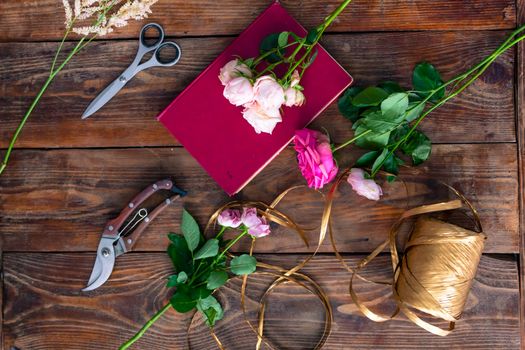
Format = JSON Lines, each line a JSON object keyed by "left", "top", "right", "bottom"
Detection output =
{"left": 294, "top": 129, "right": 339, "bottom": 189}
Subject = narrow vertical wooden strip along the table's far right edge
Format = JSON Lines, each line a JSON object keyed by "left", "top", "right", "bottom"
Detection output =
{"left": 515, "top": 0, "right": 525, "bottom": 350}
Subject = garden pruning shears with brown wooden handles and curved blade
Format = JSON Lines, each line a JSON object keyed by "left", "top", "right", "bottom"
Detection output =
{"left": 82, "top": 179, "right": 186, "bottom": 292}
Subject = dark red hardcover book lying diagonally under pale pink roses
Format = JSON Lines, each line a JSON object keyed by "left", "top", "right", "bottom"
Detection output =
{"left": 158, "top": 2, "right": 352, "bottom": 195}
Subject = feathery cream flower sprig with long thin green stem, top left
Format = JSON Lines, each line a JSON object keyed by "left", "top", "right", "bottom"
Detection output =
{"left": 0, "top": 0, "right": 158, "bottom": 174}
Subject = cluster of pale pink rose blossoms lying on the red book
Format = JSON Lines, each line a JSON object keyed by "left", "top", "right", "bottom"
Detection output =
{"left": 219, "top": 59, "right": 305, "bottom": 134}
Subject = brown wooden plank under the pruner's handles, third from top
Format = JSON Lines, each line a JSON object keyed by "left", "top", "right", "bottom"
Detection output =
{"left": 0, "top": 144, "right": 518, "bottom": 253}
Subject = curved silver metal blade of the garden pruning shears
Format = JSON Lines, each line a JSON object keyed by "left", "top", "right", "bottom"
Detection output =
{"left": 82, "top": 237, "right": 115, "bottom": 292}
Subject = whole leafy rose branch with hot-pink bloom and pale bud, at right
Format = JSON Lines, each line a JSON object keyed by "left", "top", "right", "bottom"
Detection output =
{"left": 294, "top": 26, "right": 525, "bottom": 200}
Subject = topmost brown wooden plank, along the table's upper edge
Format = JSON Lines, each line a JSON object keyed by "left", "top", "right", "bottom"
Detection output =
{"left": 0, "top": 0, "right": 516, "bottom": 41}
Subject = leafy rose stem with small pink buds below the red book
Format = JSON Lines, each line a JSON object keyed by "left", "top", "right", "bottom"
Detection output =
{"left": 120, "top": 208, "right": 270, "bottom": 350}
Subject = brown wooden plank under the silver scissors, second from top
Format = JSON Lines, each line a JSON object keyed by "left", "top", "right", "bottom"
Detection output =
{"left": 0, "top": 31, "right": 516, "bottom": 148}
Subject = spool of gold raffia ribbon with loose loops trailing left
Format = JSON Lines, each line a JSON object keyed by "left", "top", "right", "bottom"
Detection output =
{"left": 336, "top": 178, "right": 486, "bottom": 336}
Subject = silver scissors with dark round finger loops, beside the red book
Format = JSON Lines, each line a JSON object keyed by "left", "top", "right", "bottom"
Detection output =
{"left": 82, "top": 23, "right": 182, "bottom": 119}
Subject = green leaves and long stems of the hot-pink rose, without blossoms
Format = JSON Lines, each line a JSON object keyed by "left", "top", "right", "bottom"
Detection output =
{"left": 334, "top": 26, "right": 525, "bottom": 178}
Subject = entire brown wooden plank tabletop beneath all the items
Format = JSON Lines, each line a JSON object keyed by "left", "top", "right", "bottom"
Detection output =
{"left": 0, "top": 0, "right": 525, "bottom": 350}
